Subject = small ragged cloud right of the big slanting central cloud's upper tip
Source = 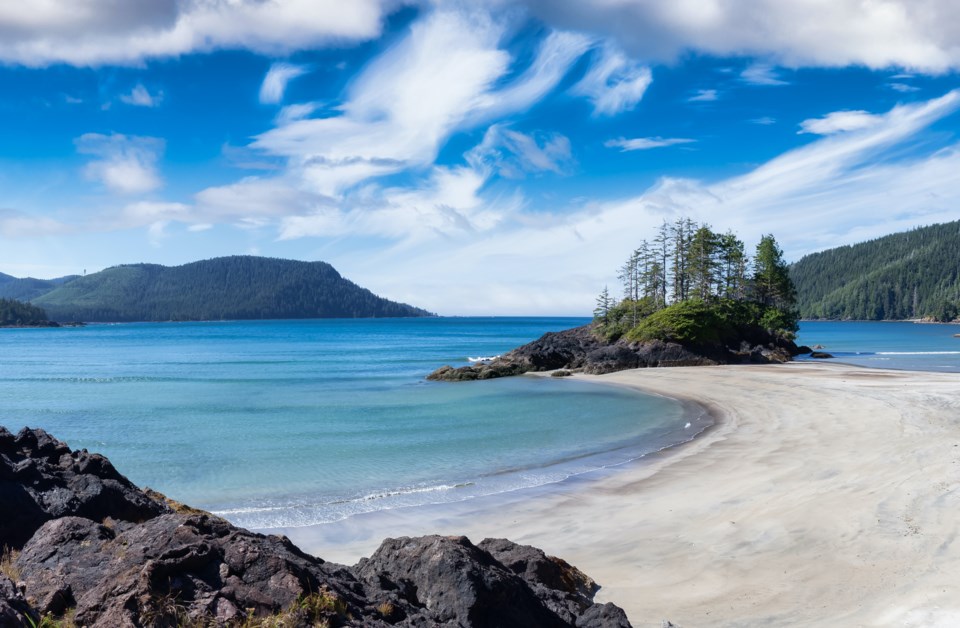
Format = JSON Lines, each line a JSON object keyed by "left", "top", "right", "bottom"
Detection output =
{"left": 572, "top": 45, "right": 653, "bottom": 116}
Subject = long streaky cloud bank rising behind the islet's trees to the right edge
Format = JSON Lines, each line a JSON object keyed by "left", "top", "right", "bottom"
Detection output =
{"left": 339, "top": 91, "right": 960, "bottom": 315}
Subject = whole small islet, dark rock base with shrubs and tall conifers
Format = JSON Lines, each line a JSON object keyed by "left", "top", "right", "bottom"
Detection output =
{"left": 427, "top": 226, "right": 810, "bottom": 381}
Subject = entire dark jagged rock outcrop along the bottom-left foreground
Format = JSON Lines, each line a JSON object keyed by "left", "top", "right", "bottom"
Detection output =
{"left": 0, "top": 428, "right": 630, "bottom": 627}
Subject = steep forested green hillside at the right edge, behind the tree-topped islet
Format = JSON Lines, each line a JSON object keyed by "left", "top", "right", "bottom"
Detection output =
{"left": 790, "top": 221, "right": 960, "bottom": 320}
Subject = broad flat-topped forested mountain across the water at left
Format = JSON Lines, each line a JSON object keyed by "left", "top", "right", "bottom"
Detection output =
{"left": 25, "top": 256, "right": 431, "bottom": 322}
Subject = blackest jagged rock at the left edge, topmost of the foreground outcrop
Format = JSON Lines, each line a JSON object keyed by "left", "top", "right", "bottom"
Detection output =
{"left": 0, "top": 427, "right": 168, "bottom": 547}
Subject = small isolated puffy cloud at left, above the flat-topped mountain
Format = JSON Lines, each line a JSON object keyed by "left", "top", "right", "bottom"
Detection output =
{"left": 74, "top": 133, "right": 164, "bottom": 194}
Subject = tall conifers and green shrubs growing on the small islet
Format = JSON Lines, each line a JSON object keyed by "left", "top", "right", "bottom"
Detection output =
{"left": 594, "top": 218, "right": 797, "bottom": 345}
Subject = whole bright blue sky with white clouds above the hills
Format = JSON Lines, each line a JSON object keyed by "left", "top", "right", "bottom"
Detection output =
{"left": 0, "top": 0, "right": 960, "bottom": 315}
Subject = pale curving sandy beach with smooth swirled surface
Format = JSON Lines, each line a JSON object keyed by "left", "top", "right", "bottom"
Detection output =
{"left": 283, "top": 363, "right": 960, "bottom": 627}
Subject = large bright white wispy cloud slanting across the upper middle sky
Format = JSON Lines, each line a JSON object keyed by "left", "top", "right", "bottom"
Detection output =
{"left": 251, "top": 9, "right": 590, "bottom": 197}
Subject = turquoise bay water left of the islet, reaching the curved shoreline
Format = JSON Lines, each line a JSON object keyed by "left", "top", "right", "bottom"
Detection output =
{"left": 0, "top": 318, "right": 708, "bottom": 528}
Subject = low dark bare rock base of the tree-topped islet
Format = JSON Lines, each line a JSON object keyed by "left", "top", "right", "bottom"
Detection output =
{"left": 427, "top": 325, "right": 800, "bottom": 381}
